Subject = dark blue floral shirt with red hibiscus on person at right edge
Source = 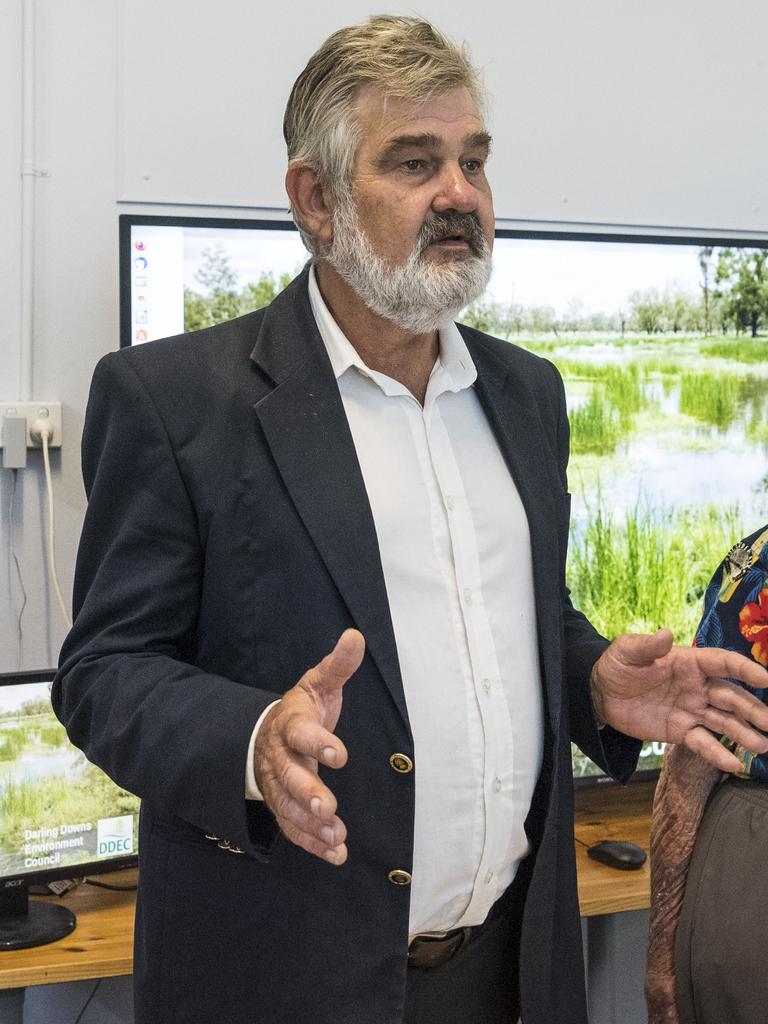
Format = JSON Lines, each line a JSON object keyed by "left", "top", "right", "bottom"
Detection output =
{"left": 693, "top": 526, "right": 768, "bottom": 782}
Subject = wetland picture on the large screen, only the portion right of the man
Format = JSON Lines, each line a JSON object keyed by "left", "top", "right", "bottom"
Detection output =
{"left": 473, "top": 239, "right": 768, "bottom": 775}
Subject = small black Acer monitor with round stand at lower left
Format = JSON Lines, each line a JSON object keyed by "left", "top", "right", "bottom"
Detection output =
{"left": 0, "top": 670, "right": 139, "bottom": 950}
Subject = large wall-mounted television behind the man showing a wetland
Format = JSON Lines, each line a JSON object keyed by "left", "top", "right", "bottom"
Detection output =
{"left": 120, "top": 215, "right": 768, "bottom": 784}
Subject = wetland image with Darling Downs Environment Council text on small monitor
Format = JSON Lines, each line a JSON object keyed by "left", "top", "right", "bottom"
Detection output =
{"left": 0, "top": 682, "right": 139, "bottom": 876}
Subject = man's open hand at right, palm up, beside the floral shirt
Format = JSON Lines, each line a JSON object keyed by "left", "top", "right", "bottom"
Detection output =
{"left": 591, "top": 630, "right": 768, "bottom": 772}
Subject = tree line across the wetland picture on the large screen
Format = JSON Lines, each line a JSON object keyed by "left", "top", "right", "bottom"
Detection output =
{"left": 184, "top": 239, "right": 768, "bottom": 339}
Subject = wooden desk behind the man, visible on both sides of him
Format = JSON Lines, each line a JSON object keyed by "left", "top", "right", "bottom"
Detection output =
{"left": 0, "top": 783, "right": 653, "bottom": 989}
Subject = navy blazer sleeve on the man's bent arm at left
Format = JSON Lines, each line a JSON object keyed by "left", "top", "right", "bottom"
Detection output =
{"left": 52, "top": 352, "right": 280, "bottom": 855}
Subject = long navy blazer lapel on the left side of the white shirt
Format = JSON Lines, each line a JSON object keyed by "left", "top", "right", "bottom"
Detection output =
{"left": 251, "top": 269, "right": 408, "bottom": 724}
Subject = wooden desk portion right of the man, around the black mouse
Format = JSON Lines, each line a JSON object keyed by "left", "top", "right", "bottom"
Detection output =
{"left": 574, "top": 782, "right": 655, "bottom": 918}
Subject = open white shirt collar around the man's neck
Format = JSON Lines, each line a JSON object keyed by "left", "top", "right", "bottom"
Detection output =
{"left": 309, "top": 264, "right": 477, "bottom": 394}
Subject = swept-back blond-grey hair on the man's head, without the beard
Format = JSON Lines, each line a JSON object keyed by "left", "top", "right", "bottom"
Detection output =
{"left": 283, "top": 14, "right": 487, "bottom": 256}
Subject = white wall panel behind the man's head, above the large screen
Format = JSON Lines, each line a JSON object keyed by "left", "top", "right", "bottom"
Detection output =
{"left": 118, "top": 0, "right": 768, "bottom": 230}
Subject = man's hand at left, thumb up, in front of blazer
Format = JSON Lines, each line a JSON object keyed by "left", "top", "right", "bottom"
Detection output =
{"left": 253, "top": 630, "right": 366, "bottom": 864}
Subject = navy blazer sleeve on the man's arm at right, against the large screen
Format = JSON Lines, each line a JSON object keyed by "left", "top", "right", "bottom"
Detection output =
{"left": 549, "top": 364, "right": 642, "bottom": 781}
